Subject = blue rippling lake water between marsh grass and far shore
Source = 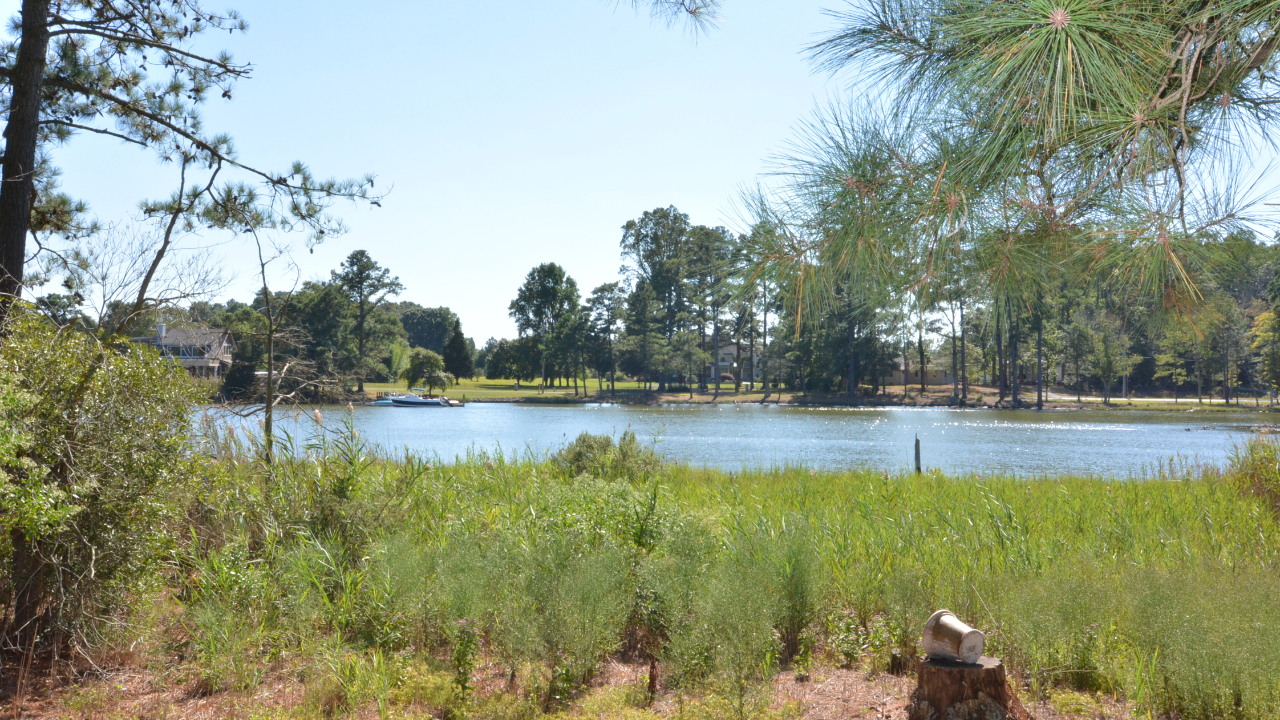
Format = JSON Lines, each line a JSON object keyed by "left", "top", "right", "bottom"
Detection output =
{"left": 232, "top": 404, "right": 1275, "bottom": 477}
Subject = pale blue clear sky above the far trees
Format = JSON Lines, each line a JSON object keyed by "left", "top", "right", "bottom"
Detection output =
{"left": 0, "top": 0, "right": 850, "bottom": 342}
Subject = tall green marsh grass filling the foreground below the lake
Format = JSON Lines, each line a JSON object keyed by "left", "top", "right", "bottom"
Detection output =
{"left": 165, "top": 422, "right": 1280, "bottom": 719}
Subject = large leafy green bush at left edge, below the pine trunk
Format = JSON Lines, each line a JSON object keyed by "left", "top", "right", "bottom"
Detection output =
{"left": 0, "top": 304, "right": 198, "bottom": 632}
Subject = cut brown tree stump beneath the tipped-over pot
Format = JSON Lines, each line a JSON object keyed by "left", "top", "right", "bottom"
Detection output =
{"left": 908, "top": 656, "right": 1032, "bottom": 720}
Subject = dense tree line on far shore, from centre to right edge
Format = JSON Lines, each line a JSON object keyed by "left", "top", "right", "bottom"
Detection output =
{"left": 479, "top": 208, "right": 1280, "bottom": 406}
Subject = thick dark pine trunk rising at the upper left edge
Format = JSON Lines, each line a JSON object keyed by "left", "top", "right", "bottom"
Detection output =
{"left": 0, "top": 0, "right": 49, "bottom": 313}
